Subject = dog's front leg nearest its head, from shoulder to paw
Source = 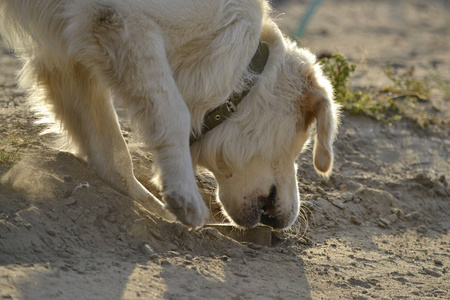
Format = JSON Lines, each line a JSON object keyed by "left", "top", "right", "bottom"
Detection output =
{"left": 64, "top": 4, "right": 208, "bottom": 227}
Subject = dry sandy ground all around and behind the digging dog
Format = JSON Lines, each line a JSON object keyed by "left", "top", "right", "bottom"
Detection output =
{"left": 0, "top": 0, "right": 450, "bottom": 300}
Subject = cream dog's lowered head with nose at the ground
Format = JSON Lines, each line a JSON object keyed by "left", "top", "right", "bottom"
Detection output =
{"left": 192, "top": 44, "right": 338, "bottom": 229}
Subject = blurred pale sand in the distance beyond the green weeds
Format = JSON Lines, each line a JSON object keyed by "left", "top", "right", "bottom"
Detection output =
{"left": 271, "top": 0, "right": 450, "bottom": 88}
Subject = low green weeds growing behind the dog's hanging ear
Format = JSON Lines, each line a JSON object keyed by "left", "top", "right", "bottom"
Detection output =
{"left": 321, "top": 54, "right": 450, "bottom": 128}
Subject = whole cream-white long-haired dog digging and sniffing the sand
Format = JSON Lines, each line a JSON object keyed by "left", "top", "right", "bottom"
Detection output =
{"left": 0, "top": 0, "right": 338, "bottom": 228}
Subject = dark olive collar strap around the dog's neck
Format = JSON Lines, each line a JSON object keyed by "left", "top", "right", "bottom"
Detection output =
{"left": 189, "top": 41, "right": 269, "bottom": 145}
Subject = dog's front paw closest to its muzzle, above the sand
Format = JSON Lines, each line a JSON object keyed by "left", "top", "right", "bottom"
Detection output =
{"left": 164, "top": 191, "right": 209, "bottom": 228}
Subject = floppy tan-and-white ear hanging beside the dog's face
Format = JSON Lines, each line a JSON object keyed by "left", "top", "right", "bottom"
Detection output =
{"left": 299, "top": 76, "right": 339, "bottom": 177}
